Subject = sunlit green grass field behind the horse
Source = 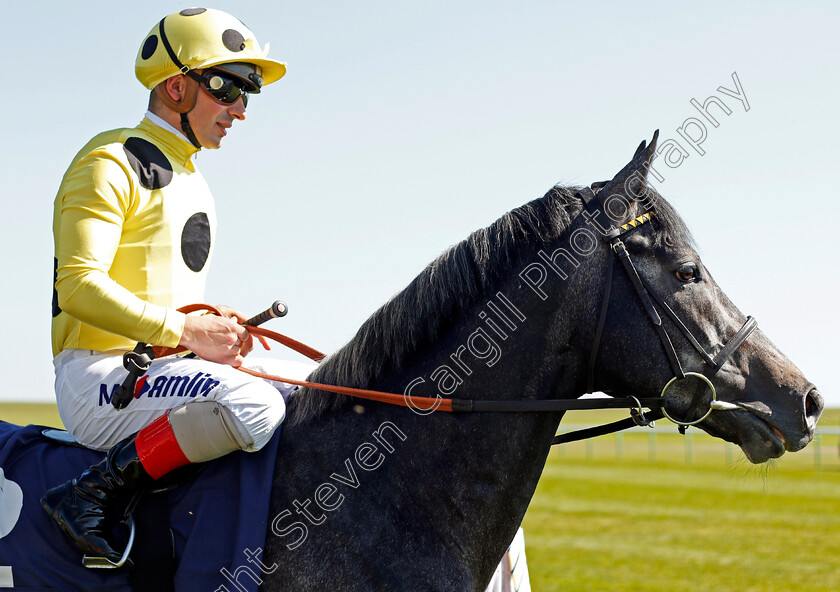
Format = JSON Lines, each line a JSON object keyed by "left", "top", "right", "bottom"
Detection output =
{"left": 0, "top": 404, "right": 840, "bottom": 592}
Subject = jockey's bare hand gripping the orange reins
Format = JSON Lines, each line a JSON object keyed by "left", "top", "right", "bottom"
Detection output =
{"left": 178, "top": 309, "right": 254, "bottom": 368}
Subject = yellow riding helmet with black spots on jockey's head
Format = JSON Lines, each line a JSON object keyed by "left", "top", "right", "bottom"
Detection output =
{"left": 134, "top": 8, "right": 286, "bottom": 92}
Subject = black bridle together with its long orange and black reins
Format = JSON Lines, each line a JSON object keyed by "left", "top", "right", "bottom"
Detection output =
{"left": 112, "top": 188, "right": 757, "bottom": 444}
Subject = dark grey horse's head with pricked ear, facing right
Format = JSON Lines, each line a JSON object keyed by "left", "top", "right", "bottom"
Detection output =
{"left": 589, "top": 135, "right": 823, "bottom": 463}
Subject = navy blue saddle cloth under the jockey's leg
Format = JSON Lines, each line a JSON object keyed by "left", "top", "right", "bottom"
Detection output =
{"left": 0, "top": 421, "right": 279, "bottom": 592}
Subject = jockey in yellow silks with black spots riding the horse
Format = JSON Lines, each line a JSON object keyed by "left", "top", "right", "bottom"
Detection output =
{"left": 41, "top": 8, "right": 310, "bottom": 561}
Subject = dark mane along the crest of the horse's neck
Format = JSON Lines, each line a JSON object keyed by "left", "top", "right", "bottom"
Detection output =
{"left": 289, "top": 184, "right": 693, "bottom": 423}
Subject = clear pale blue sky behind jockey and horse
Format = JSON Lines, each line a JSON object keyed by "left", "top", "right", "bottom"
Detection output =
{"left": 0, "top": 0, "right": 840, "bottom": 406}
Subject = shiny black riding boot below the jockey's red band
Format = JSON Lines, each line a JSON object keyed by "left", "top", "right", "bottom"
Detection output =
{"left": 41, "top": 436, "right": 153, "bottom": 563}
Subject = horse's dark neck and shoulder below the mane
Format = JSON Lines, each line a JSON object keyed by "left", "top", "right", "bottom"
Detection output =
{"left": 269, "top": 256, "right": 582, "bottom": 590}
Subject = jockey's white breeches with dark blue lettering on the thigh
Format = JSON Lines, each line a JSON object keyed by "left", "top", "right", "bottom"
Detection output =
{"left": 53, "top": 349, "right": 315, "bottom": 452}
